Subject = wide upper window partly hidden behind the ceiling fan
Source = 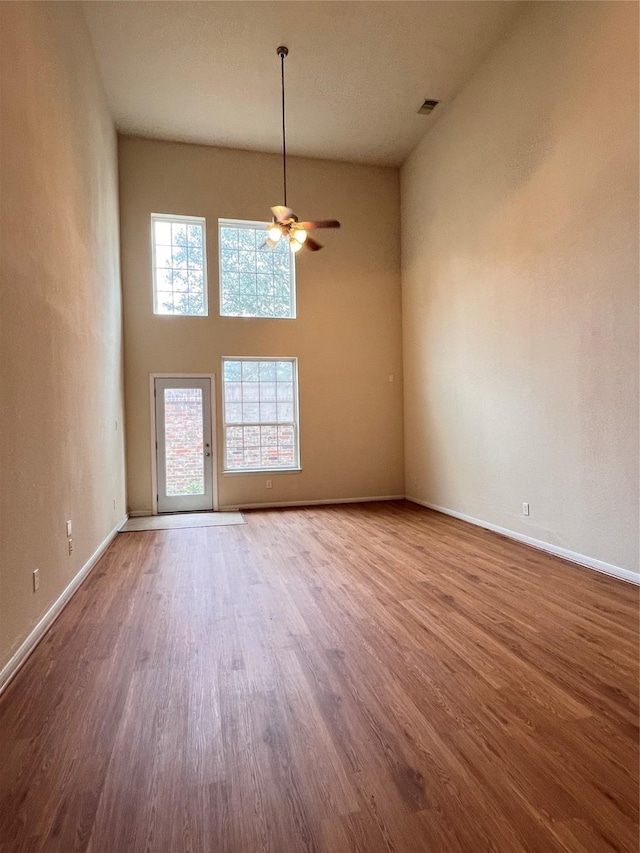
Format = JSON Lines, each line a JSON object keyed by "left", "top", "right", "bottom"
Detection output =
{"left": 218, "top": 219, "right": 296, "bottom": 319}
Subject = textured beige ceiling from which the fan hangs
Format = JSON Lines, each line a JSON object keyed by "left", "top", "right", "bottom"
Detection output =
{"left": 83, "top": 0, "right": 522, "bottom": 165}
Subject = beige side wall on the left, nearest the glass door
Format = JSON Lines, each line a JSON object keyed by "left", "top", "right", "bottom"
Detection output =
{"left": 0, "top": 3, "right": 125, "bottom": 670}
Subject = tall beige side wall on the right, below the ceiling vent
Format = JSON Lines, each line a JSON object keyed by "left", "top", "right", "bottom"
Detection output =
{"left": 402, "top": 2, "right": 638, "bottom": 571}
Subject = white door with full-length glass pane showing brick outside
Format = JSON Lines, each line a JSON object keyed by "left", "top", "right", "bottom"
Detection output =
{"left": 154, "top": 376, "right": 215, "bottom": 512}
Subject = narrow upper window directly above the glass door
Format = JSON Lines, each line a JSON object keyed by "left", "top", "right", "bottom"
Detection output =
{"left": 151, "top": 213, "right": 207, "bottom": 317}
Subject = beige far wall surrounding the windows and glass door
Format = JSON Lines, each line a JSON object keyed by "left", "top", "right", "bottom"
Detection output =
{"left": 119, "top": 137, "right": 404, "bottom": 511}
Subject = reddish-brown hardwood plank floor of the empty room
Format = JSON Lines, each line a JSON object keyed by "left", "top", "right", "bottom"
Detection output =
{"left": 0, "top": 502, "right": 638, "bottom": 853}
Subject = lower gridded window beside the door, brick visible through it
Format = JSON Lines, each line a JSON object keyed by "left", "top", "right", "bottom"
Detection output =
{"left": 222, "top": 358, "right": 300, "bottom": 471}
